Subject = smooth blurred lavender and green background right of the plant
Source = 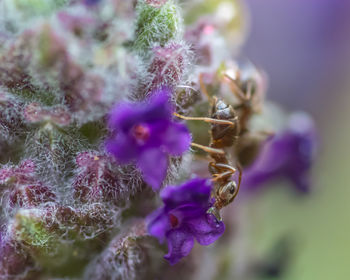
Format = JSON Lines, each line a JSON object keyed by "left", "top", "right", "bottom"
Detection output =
{"left": 239, "top": 0, "right": 350, "bottom": 280}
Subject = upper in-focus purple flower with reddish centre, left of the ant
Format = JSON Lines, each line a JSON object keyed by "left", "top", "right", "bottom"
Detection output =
{"left": 106, "top": 88, "right": 191, "bottom": 190}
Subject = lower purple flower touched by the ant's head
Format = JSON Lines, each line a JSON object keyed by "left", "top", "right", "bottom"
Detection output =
{"left": 147, "top": 178, "right": 225, "bottom": 265}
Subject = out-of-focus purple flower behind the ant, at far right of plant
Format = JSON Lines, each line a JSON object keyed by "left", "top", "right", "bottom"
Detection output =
{"left": 242, "top": 113, "right": 317, "bottom": 193}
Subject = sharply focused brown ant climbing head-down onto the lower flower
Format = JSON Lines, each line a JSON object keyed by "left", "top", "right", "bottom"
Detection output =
{"left": 174, "top": 77, "right": 242, "bottom": 220}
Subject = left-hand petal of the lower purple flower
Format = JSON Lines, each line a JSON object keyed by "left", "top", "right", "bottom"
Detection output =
{"left": 146, "top": 208, "right": 171, "bottom": 243}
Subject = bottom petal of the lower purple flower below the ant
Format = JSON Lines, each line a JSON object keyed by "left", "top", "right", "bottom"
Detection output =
{"left": 164, "top": 228, "right": 194, "bottom": 265}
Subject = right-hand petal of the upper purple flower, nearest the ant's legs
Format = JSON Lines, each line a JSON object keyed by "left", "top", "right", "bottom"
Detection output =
{"left": 164, "top": 123, "right": 191, "bottom": 156}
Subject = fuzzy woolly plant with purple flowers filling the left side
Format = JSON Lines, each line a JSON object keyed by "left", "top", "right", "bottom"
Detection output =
{"left": 0, "top": 0, "right": 315, "bottom": 280}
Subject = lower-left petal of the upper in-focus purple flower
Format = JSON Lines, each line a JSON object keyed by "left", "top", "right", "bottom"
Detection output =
{"left": 105, "top": 133, "right": 140, "bottom": 163}
